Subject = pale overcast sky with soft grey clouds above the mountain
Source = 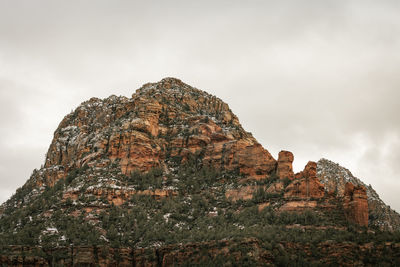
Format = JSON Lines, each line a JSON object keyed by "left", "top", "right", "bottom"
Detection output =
{"left": 0, "top": 0, "right": 400, "bottom": 211}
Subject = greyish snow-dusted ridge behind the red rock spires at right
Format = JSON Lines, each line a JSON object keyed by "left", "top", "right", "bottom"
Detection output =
{"left": 317, "top": 159, "right": 400, "bottom": 231}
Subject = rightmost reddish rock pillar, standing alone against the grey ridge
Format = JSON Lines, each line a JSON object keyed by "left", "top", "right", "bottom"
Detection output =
{"left": 343, "top": 182, "right": 368, "bottom": 226}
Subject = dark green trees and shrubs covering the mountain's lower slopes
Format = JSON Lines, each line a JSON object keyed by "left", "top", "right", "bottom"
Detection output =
{"left": 0, "top": 159, "right": 400, "bottom": 266}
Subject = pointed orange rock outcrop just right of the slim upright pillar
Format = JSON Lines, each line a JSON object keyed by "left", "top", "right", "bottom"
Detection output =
{"left": 284, "top": 161, "right": 325, "bottom": 199}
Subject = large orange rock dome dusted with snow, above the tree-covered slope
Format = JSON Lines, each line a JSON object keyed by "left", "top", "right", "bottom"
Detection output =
{"left": 41, "top": 78, "right": 276, "bottom": 184}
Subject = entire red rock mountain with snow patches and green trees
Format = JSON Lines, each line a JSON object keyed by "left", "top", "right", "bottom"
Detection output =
{"left": 0, "top": 78, "right": 400, "bottom": 266}
